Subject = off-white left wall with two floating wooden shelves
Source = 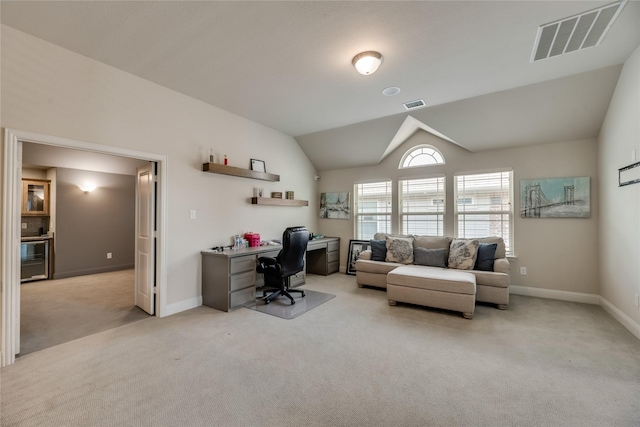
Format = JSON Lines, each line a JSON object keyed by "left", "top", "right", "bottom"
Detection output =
{"left": 1, "top": 26, "right": 318, "bottom": 305}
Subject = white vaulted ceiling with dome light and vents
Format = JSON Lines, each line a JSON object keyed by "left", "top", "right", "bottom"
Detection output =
{"left": 1, "top": 0, "right": 640, "bottom": 170}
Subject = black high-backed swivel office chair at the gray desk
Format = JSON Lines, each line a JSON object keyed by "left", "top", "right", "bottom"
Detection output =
{"left": 256, "top": 227, "right": 309, "bottom": 304}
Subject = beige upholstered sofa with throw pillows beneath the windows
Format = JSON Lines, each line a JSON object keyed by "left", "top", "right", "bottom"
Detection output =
{"left": 355, "top": 233, "right": 510, "bottom": 310}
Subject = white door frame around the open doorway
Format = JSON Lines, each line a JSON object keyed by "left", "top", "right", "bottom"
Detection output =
{"left": 0, "top": 128, "right": 168, "bottom": 367}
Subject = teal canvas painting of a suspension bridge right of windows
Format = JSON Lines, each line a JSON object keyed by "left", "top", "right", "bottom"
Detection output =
{"left": 520, "top": 176, "right": 591, "bottom": 218}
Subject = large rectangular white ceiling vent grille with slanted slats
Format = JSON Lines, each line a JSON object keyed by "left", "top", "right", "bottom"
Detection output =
{"left": 531, "top": 0, "right": 628, "bottom": 62}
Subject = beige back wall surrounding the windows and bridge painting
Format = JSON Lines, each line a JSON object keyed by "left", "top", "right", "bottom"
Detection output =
{"left": 319, "top": 131, "right": 599, "bottom": 294}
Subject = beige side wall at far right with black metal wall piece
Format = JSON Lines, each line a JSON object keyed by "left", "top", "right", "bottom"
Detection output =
{"left": 598, "top": 47, "right": 640, "bottom": 324}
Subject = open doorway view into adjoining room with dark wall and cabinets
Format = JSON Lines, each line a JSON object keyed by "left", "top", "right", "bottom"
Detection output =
{"left": 18, "top": 142, "right": 150, "bottom": 357}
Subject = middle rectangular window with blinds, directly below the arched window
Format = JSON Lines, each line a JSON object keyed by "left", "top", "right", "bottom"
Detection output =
{"left": 398, "top": 176, "right": 446, "bottom": 236}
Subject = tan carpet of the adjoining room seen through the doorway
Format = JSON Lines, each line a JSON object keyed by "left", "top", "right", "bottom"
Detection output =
{"left": 20, "top": 269, "right": 149, "bottom": 357}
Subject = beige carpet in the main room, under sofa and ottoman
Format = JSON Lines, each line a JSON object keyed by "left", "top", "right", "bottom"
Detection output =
{"left": 1, "top": 274, "right": 640, "bottom": 426}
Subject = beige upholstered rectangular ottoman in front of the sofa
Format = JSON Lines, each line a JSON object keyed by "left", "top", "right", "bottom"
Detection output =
{"left": 387, "top": 265, "right": 476, "bottom": 319}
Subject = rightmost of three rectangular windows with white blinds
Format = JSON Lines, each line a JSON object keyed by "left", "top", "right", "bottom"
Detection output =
{"left": 454, "top": 171, "right": 513, "bottom": 255}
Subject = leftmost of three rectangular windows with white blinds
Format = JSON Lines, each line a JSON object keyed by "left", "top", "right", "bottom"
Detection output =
{"left": 354, "top": 181, "right": 391, "bottom": 240}
